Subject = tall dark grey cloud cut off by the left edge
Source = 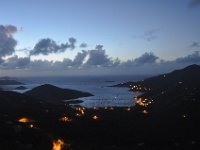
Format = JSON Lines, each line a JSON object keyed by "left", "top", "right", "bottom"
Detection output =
{"left": 0, "top": 25, "right": 18, "bottom": 59}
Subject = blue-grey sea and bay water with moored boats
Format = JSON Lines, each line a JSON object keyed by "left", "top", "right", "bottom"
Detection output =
{"left": 3, "top": 75, "right": 147, "bottom": 108}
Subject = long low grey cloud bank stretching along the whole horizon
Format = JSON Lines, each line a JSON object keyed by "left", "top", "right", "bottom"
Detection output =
{"left": 0, "top": 49, "right": 200, "bottom": 76}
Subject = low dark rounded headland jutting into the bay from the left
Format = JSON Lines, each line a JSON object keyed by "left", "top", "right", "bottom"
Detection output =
{"left": 25, "top": 84, "right": 92, "bottom": 101}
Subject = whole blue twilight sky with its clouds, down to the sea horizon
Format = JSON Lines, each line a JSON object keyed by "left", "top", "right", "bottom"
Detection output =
{"left": 0, "top": 0, "right": 200, "bottom": 76}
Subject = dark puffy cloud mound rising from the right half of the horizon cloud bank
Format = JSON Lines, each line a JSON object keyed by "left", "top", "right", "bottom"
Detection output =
{"left": 133, "top": 52, "right": 158, "bottom": 64}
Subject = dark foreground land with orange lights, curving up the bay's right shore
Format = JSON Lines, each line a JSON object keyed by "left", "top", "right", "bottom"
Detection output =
{"left": 0, "top": 64, "right": 200, "bottom": 150}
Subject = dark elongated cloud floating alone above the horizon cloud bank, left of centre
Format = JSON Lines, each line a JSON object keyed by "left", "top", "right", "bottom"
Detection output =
{"left": 30, "top": 37, "right": 76, "bottom": 55}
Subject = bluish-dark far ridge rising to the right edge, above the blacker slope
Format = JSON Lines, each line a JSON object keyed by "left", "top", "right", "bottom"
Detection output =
{"left": 115, "top": 64, "right": 200, "bottom": 89}
